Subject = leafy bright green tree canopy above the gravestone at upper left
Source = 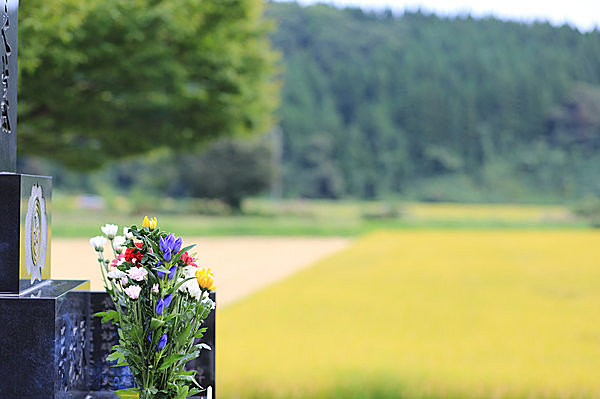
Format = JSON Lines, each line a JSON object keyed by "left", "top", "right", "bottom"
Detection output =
{"left": 18, "top": 0, "right": 277, "bottom": 169}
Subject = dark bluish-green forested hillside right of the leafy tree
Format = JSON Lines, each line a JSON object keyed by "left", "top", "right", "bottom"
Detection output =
{"left": 267, "top": 3, "right": 600, "bottom": 200}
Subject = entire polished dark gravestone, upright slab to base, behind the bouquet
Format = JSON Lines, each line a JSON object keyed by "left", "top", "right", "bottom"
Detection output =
{"left": 0, "top": 0, "right": 215, "bottom": 399}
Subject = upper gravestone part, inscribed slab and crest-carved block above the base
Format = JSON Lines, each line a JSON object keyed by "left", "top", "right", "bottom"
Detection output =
{"left": 0, "top": 0, "right": 52, "bottom": 295}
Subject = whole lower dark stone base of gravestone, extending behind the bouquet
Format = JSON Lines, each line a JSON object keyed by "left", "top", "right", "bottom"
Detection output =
{"left": 0, "top": 280, "right": 216, "bottom": 399}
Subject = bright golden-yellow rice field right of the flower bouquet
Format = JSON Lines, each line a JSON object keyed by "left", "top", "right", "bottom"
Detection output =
{"left": 217, "top": 230, "right": 600, "bottom": 398}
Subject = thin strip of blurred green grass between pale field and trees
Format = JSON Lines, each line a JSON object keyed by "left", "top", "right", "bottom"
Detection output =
{"left": 52, "top": 195, "right": 585, "bottom": 237}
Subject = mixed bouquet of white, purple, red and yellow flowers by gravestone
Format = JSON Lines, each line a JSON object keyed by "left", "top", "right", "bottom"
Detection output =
{"left": 90, "top": 217, "right": 215, "bottom": 399}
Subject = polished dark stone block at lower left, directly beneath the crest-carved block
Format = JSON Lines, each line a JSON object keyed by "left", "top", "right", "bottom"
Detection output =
{"left": 0, "top": 280, "right": 89, "bottom": 399}
